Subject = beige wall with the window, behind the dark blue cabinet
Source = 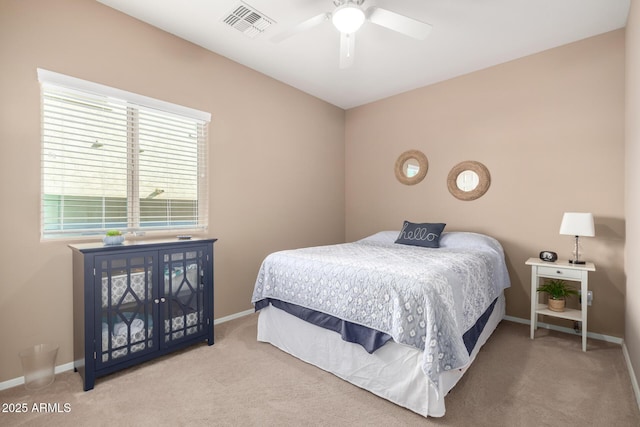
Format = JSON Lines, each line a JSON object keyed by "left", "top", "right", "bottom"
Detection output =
{"left": 0, "top": 0, "right": 344, "bottom": 382}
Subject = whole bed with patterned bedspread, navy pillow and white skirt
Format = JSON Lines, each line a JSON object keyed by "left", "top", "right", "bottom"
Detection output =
{"left": 252, "top": 227, "right": 510, "bottom": 417}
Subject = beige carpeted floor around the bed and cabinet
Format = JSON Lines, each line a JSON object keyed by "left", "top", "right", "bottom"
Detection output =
{"left": 0, "top": 315, "right": 640, "bottom": 427}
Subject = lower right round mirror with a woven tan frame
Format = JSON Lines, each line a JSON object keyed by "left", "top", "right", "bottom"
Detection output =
{"left": 447, "top": 160, "right": 491, "bottom": 200}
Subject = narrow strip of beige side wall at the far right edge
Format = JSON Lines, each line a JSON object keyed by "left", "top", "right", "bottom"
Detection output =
{"left": 624, "top": 0, "right": 640, "bottom": 394}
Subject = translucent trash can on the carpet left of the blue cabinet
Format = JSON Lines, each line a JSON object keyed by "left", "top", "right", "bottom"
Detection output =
{"left": 19, "top": 344, "right": 58, "bottom": 390}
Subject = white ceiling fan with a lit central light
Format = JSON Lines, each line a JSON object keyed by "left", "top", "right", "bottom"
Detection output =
{"left": 271, "top": 0, "right": 431, "bottom": 68}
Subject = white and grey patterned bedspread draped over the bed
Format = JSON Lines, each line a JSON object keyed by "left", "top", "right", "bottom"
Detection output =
{"left": 252, "top": 232, "right": 509, "bottom": 389}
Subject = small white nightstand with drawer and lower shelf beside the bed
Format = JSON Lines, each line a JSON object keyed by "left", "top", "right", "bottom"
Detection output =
{"left": 526, "top": 258, "right": 596, "bottom": 351}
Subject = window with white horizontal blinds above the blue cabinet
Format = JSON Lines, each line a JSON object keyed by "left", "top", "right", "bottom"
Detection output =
{"left": 38, "top": 69, "right": 210, "bottom": 239}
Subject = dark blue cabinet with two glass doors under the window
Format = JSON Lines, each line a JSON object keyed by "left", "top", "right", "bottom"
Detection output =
{"left": 69, "top": 239, "right": 216, "bottom": 391}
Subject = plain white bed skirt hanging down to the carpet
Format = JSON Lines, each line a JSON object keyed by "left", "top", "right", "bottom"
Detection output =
{"left": 258, "top": 294, "right": 505, "bottom": 417}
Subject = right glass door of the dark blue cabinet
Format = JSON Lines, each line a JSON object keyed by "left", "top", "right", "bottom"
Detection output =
{"left": 160, "top": 247, "right": 206, "bottom": 346}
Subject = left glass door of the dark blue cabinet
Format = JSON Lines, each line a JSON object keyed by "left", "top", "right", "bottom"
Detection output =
{"left": 95, "top": 252, "right": 158, "bottom": 366}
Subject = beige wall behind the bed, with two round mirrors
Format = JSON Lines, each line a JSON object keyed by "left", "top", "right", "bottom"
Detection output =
{"left": 346, "top": 30, "right": 625, "bottom": 337}
